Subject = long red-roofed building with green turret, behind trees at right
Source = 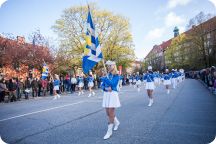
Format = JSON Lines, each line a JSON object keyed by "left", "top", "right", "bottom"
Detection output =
{"left": 145, "top": 17, "right": 216, "bottom": 70}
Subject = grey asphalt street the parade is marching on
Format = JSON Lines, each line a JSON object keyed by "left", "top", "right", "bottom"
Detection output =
{"left": 0, "top": 79, "right": 216, "bottom": 144}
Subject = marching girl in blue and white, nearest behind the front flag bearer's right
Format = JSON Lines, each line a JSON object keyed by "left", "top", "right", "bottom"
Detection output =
{"left": 143, "top": 66, "right": 155, "bottom": 107}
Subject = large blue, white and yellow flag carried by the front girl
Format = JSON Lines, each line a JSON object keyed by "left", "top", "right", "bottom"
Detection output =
{"left": 82, "top": 6, "right": 103, "bottom": 73}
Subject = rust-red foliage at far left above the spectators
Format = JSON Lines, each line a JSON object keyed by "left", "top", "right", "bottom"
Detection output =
{"left": 0, "top": 32, "right": 53, "bottom": 77}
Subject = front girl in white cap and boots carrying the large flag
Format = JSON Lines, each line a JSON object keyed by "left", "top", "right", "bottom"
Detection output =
{"left": 101, "top": 61, "right": 121, "bottom": 140}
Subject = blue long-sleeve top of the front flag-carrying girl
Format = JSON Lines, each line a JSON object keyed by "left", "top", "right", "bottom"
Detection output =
{"left": 101, "top": 73, "right": 119, "bottom": 92}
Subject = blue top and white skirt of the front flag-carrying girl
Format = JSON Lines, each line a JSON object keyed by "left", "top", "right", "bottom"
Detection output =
{"left": 101, "top": 73, "right": 121, "bottom": 108}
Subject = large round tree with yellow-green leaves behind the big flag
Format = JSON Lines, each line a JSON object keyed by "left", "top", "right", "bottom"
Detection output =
{"left": 53, "top": 4, "right": 135, "bottom": 73}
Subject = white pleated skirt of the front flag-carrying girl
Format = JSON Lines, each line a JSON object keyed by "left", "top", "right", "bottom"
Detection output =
{"left": 102, "top": 91, "right": 121, "bottom": 108}
